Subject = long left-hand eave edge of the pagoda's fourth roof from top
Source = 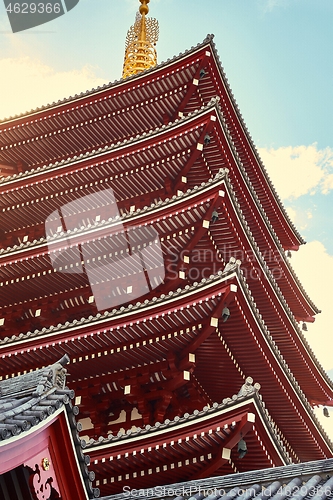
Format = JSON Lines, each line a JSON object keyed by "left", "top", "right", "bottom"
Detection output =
{"left": 0, "top": 271, "right": 236, "bottom": 373}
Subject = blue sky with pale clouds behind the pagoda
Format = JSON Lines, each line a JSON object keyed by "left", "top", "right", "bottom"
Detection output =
{"left": 0, "top": 0, "right": 333, "bottom": 438}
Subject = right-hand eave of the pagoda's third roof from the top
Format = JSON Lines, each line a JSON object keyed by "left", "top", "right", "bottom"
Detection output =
{"left": 214, "top": 178, "right": 333, "bottom": 402}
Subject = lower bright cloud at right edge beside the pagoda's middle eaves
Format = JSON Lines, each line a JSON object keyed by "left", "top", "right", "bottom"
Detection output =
{"left": 291, "top": 241, "right": 333, "bottom": 370}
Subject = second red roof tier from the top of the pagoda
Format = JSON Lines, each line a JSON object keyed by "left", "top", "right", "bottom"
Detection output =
{"left": 1, "top": 104, "right": 318, "bottom": 321}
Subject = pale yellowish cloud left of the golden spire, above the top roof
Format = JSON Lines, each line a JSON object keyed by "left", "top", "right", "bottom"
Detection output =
{"left": 0, "top": 57, "right": 106, "bottom": 118}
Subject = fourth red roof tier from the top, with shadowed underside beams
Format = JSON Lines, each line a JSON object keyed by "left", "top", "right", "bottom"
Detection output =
{"left": 0, "top": 264, "right": 332, "bottom": 460}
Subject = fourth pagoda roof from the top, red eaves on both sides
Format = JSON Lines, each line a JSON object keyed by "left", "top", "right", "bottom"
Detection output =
{"left": 0, "top": 243, "right": 331, "bottom": 456}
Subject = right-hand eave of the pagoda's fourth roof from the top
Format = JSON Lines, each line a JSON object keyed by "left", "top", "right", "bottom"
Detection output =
{"left": 232, "top": 278, "right": 333, "bottom": 460}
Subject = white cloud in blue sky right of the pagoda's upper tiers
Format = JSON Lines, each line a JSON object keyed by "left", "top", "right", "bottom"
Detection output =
{"left": 259, "top": 144, "right": 333, "bottom": 199}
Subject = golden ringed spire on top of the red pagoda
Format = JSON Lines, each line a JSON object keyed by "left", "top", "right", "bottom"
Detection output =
{"left": 123, "top": 0, "right": 159, "bottom": 78}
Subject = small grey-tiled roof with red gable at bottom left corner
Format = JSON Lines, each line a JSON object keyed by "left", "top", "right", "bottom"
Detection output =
{"left": 0, "top": 355, "right": 99, "bottom": 500}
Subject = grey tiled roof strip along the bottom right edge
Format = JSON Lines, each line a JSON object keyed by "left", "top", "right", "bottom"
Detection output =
{"left": 101, "top": 459, "right": 333, "bottom": 500}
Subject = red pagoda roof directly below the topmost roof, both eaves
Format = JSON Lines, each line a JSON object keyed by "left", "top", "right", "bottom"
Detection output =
{"left": 0, "top": 99, "right": 319, "bottom": 321}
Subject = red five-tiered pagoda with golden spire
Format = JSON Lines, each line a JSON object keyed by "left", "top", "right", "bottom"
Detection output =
{"left": 0, "top": 0, "right": 333, "bottom": 496}
